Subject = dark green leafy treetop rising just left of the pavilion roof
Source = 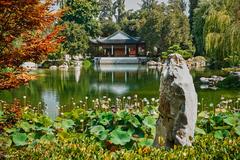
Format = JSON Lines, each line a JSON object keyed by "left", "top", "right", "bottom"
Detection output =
{"left": 62, "top": 0, "right": 100, "bottom": 37}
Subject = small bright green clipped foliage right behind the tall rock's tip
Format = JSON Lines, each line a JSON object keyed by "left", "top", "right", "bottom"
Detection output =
{"left": 162, "top": 45, "right": 192, "bottom": 59}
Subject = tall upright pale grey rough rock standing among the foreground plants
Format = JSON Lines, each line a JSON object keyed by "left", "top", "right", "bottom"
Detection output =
{"left": 154, "top": 54, "right": 197, "bottom": 147}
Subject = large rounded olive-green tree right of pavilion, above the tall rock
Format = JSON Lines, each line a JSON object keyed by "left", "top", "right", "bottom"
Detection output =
{"left": 139, "top": 1, "right": 192, "bottom": 52}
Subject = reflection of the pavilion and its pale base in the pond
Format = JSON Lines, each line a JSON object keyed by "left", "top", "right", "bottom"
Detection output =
{"left": 91, "top": 64, "right": 150, "bottom": 96}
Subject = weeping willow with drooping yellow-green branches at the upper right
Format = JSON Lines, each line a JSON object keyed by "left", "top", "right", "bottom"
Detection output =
{"left": 203, "top": 0, "right": 240, "bottom": 67}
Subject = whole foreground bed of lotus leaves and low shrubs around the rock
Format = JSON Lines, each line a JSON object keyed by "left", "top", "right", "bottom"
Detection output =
{"left": 0, "top": 100, "right": 240, "bottom": 159}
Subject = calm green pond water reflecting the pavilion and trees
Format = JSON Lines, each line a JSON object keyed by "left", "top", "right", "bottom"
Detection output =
{"left": 0, "top": 65, "right": 240, "bottom": 116}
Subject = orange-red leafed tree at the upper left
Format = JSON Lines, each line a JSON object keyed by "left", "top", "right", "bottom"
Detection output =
{"left": 0, "top": 0, "right": 62, "bottom": 68}
